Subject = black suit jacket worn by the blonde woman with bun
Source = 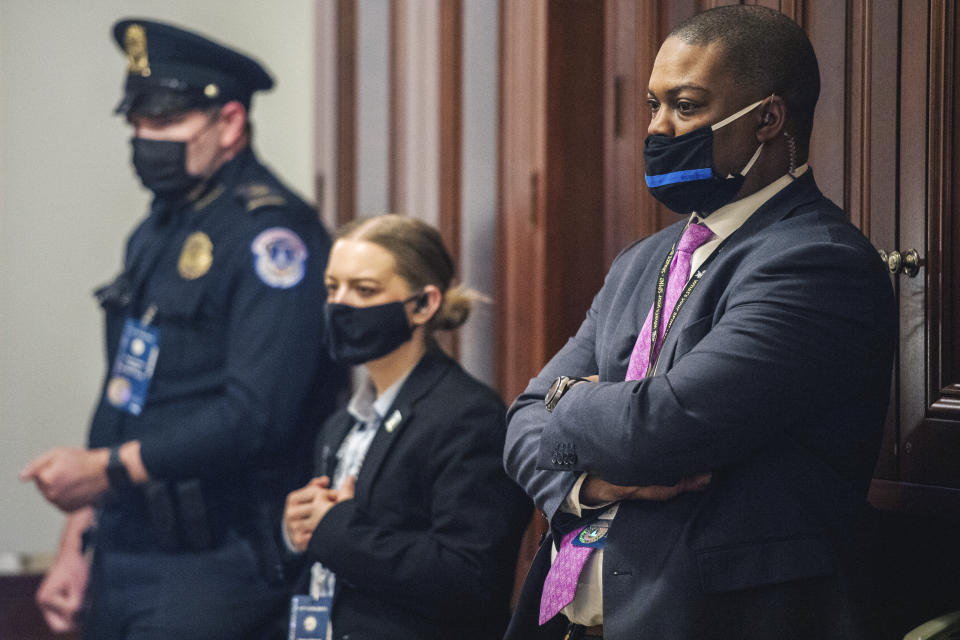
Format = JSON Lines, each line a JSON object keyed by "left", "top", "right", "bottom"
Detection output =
{"left": 307, "top": 349, "right": 532, "bottom": 640}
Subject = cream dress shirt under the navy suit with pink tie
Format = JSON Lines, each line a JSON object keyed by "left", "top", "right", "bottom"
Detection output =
{"left": 553, "top": 164, "right": 807, "bottom": 626}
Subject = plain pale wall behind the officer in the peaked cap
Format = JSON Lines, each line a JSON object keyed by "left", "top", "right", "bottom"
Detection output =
{"left": 0, "top": 0, "right": 315, "bottom": 552}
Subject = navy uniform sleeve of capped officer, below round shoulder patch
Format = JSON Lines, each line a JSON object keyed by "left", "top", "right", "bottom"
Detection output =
{"left": 141, "top": 211, "right": 328, "bottom": 479}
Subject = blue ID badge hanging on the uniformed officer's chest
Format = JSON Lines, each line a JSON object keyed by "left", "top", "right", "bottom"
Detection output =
{"left": 106, "top": 306, "right": 160, "bottom": 416}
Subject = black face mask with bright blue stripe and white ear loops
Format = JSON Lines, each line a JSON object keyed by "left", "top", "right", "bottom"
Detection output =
{"left": 643, "top": 100, "right": 763, "bottom": 216}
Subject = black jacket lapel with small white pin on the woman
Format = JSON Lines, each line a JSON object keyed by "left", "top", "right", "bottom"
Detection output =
{"left": 357, "top": 351, "right": 451, "bottom": 496}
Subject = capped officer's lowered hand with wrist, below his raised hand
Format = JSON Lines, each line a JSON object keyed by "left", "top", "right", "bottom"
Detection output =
{"left": 36, "top": 508, "right": 93, "bottom": 633}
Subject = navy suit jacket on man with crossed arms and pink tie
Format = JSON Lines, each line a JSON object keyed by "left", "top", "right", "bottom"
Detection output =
{"left": 505, "top": 171, "right": 897, "bottom": 640}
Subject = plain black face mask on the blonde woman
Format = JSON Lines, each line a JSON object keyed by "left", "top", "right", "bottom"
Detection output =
{"left": 323, "top": 293, "right": 423, "bottom": 365}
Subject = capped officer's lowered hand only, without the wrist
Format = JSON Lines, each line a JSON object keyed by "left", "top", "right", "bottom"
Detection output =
{"left": 36, "top": 536, "right": 90, "bottom": 633}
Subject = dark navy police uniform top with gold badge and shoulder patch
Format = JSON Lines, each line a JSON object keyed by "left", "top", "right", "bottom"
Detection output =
{"left": 89, "top": 148, "right": 338, "bottom": 550}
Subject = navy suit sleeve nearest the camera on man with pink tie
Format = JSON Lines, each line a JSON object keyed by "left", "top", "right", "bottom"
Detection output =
{"left": 536, "top": 240, "right": 895, "bottom": 486}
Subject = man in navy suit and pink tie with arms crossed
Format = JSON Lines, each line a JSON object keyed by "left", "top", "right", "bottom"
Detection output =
{"left": 504, "top": 6, "right": 896, "bottom": 640}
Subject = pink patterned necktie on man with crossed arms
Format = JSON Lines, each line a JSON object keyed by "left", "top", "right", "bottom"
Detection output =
{"left": 540, "top": 222, "right": 713, "bottom": 624}
